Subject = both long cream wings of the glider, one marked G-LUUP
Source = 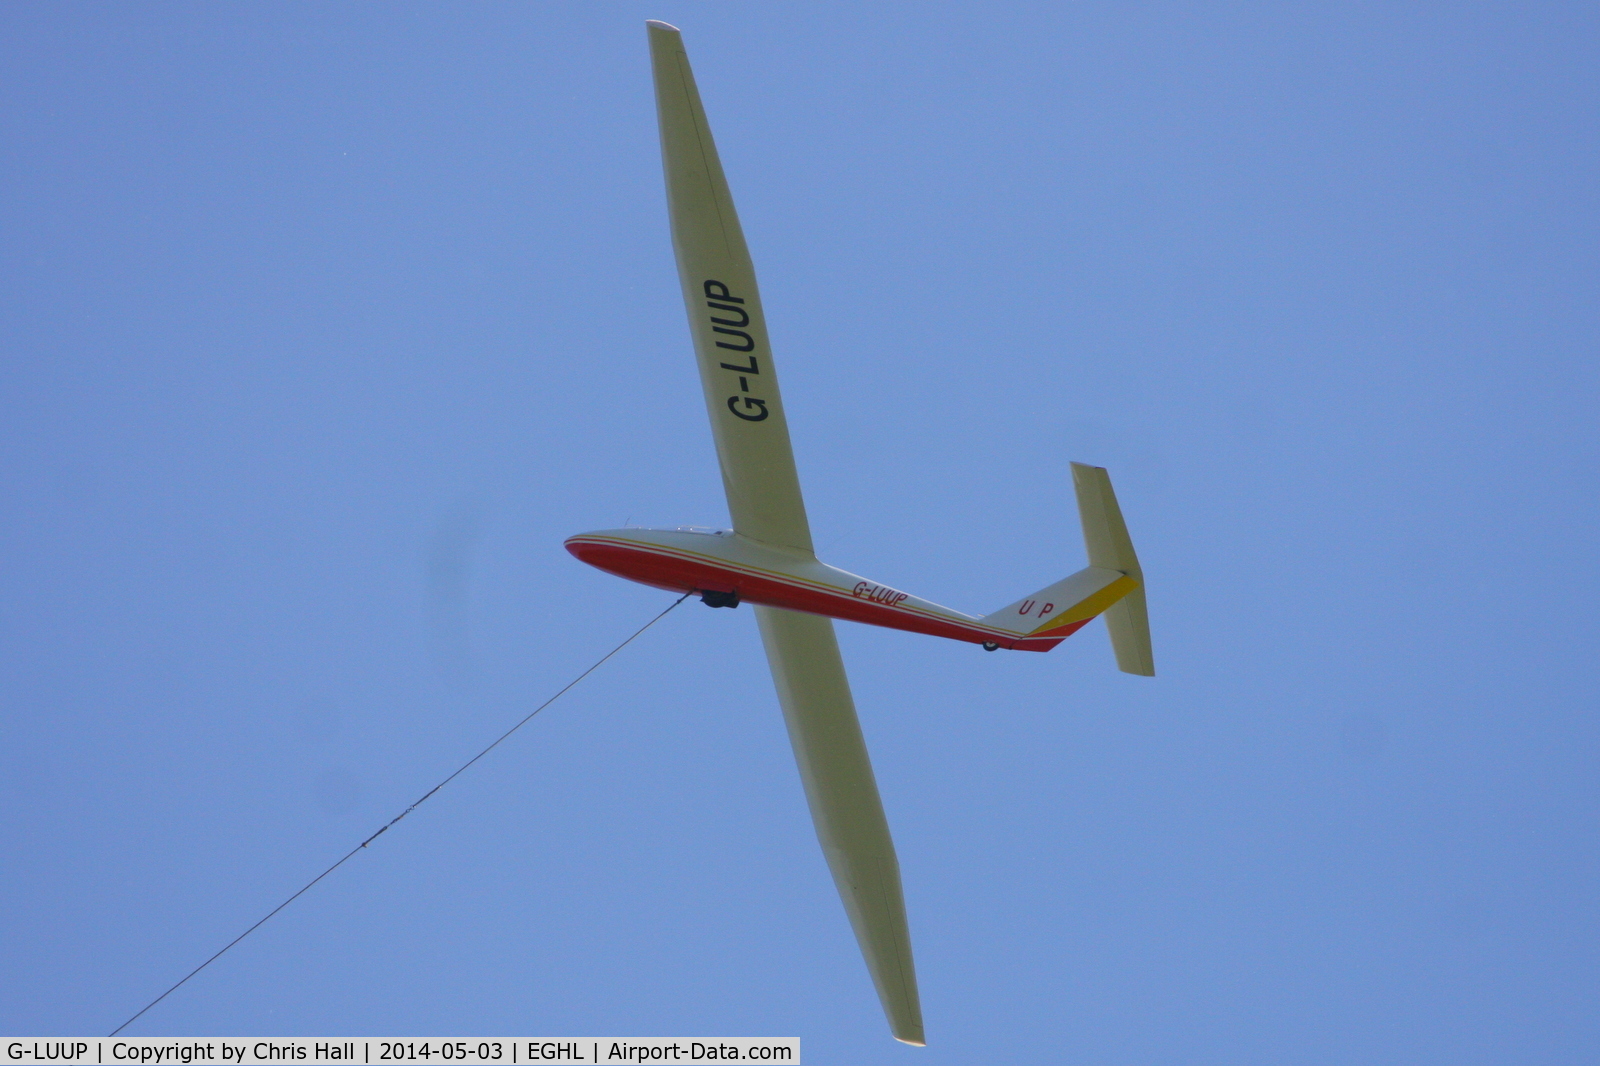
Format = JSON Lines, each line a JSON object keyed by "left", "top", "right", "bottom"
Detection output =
{"left": 648, "top": 22, "right": 923, "bottom": 1044}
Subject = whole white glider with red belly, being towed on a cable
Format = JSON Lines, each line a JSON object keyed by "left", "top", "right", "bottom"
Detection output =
{"left": 566, "top": 21, "right": 1155, "bottom": 1045}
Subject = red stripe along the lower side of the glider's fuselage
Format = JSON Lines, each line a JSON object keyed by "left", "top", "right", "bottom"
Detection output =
{"left": 566, "top": 536, "right": 1083, "bottom": 651}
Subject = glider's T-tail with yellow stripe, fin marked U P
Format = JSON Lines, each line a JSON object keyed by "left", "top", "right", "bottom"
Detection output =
{"left": 982, "top": 463, "right": 1155, "bottom": 677}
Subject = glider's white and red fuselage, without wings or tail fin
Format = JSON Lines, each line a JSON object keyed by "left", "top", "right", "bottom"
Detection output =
{"left": 566, "top": 528, "right": 1090, "bottom": 651}
